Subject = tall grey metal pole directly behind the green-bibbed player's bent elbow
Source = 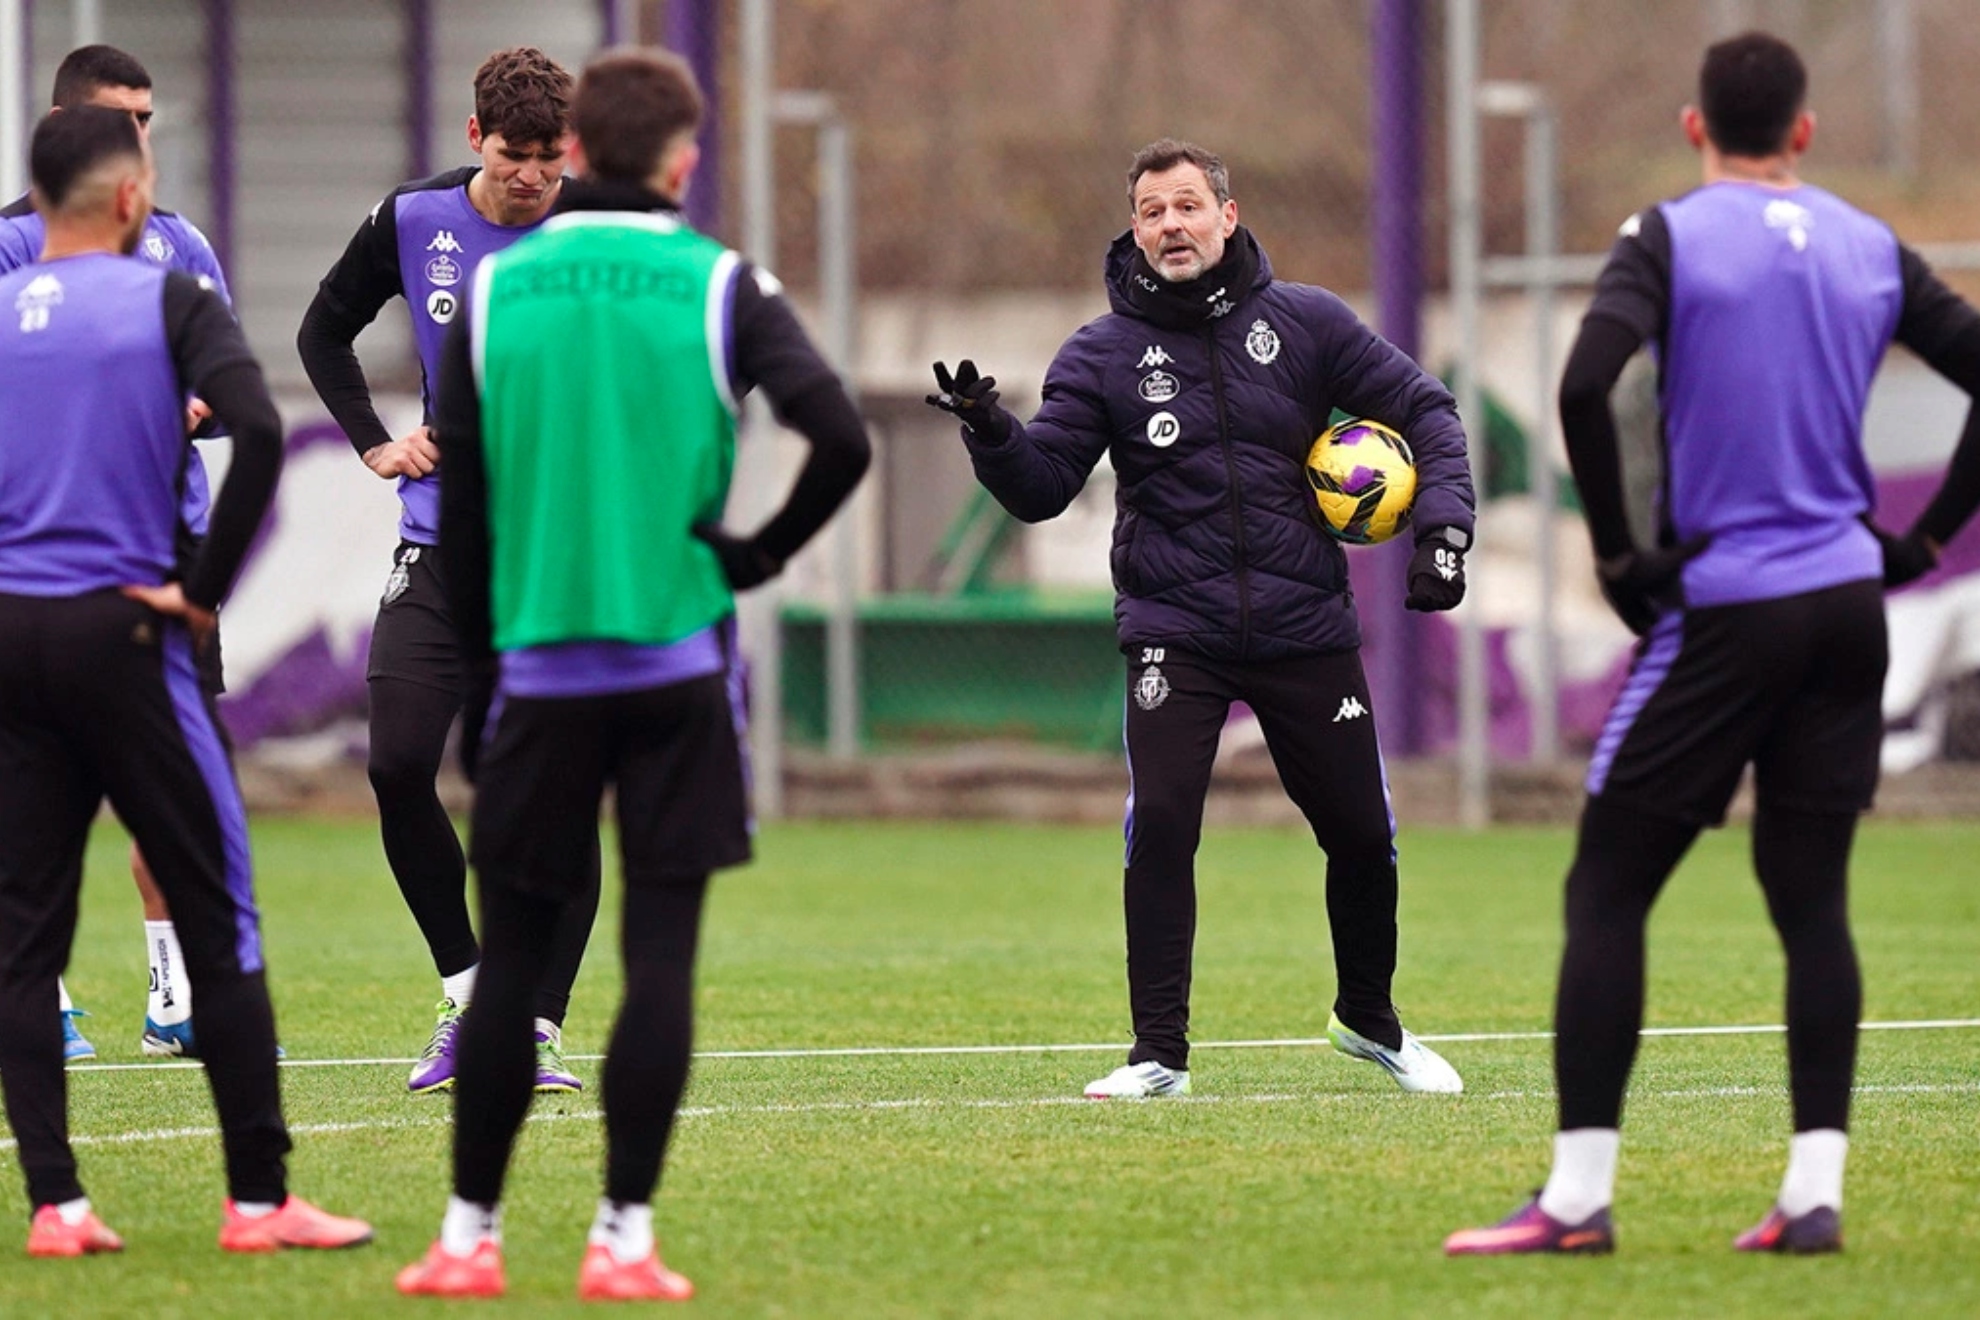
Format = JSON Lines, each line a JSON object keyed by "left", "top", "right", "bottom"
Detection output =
{"left": 737, "top": 0, "right": 784, "bottom": 819}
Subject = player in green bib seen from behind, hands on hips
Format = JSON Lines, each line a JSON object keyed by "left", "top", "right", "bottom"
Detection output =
{"left": 398, "top": 49, "right": 869, "bottom": 1298}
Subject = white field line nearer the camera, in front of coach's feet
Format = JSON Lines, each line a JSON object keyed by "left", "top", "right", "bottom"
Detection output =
{"left": 0, "top": 1083, "right": 1980, "bottom": 1152}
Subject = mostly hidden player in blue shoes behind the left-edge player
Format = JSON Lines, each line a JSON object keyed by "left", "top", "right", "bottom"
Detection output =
{"left": 0, "top": 46, "right": 228, "bottom": 1063}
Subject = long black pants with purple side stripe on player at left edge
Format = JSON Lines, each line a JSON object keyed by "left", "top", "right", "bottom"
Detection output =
{"left": 0, "top": 592, "right": 289, "bottom": 1205}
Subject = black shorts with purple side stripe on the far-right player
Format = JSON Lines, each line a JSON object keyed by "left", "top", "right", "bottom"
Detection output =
{"left": 1588, "top": 582, "right": 1889, "bottom": 825}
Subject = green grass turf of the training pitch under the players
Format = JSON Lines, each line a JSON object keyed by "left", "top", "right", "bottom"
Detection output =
{"left": 0, "top": 819, "right": 1980, "bottom": 1320}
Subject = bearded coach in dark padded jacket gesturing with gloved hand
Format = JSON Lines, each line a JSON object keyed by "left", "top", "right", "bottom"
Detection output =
{"left": 929, "top": 139, "right": 1473, "bottom": 1100}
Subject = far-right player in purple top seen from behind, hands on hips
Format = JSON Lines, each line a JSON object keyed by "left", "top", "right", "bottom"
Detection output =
{"left": 1445, "top": 34, "right": 1980, "bottom": 1255}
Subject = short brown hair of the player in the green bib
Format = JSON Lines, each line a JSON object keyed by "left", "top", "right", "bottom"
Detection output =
{"left": 574, "top": 47, "right": 703, "bottom": 182}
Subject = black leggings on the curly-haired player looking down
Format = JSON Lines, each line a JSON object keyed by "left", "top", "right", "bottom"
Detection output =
{"left": 366, "top": 677, "right": 598, "bottom": 1025}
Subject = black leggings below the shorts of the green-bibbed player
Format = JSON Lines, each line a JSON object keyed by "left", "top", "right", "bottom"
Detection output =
{"left": 453, "top": 877, "right": 709, "bottom": 1205}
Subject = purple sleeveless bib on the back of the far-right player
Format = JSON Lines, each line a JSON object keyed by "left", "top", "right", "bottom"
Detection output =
{"left": 1661, "top": 182, "right": 1905, "bottom": 606}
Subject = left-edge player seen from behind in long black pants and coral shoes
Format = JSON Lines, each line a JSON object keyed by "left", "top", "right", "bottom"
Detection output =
{"left": 0, "top": 107, "right": 370, "bottom": 1257}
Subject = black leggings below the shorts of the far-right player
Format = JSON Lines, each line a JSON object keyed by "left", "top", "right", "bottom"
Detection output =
{"left": 1554, "top": 798, "right": 1863, "bottom": 1132}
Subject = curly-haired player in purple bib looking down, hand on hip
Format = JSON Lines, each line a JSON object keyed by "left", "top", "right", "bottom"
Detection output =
{"left": 297, "top": 47, "right": 598, "bottom": 1094}
